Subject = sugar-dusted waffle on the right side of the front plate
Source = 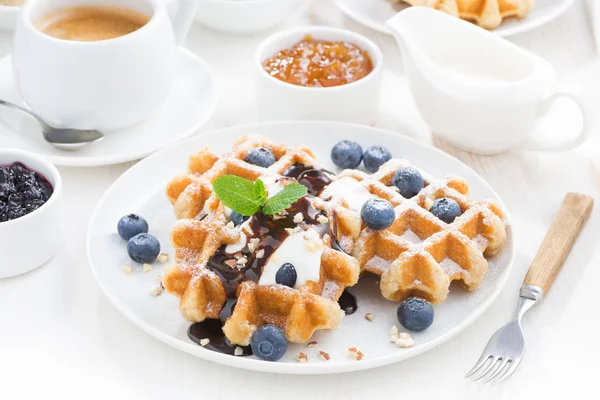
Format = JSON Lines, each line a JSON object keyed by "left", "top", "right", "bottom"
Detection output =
{"left": 324, "top": 159, "right": 506, "bottom": 303}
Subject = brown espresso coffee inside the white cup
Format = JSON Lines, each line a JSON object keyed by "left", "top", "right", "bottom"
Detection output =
{"left": 36, "top": 6, "right": 150, "bottom": 42}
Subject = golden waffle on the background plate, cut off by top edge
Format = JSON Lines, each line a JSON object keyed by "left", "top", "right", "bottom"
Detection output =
{"left": 391, "top": 0, "right": 535, "bottom": 29}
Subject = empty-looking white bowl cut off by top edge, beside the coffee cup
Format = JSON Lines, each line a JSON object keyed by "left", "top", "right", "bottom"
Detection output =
{"left": 196, "top": 0, "right": 303, "bottom": 35}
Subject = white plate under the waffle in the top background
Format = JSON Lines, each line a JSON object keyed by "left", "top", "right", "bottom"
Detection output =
{"left": 334, "top": 0, "right": 575, "bottom": 36}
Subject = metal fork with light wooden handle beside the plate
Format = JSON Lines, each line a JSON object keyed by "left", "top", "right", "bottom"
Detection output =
{"left": 465, "top": 193, "right": 594, "bottom": 385}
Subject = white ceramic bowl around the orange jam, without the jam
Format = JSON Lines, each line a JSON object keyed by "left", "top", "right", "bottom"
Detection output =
{"left": 254, "top": 26, "right": 383, "bottom": 125}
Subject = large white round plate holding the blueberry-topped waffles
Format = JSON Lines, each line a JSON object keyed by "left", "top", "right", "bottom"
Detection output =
{"left": 87, "top": 122, "right": 515, "bottom": 374}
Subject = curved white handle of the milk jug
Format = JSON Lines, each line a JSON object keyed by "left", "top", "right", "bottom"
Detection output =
{"left": 524, "top": 91, "right": 596, "bottom": 151}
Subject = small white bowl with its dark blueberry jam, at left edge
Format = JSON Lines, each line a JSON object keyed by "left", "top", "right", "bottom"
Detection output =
{"left": 0, "top": 149, "right": 63, "bottom": 278}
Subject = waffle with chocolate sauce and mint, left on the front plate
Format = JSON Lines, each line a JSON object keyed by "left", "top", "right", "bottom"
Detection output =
{"left": 163, "top": 137, "right": 360, "bottom": 345}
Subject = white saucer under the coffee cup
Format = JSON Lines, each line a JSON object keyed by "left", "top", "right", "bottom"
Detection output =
{"left": 0, "top": 49, "right": 218, "bottom": 167}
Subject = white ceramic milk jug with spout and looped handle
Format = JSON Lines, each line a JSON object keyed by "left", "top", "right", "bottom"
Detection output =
{"left": 386, "top": 7, "right": 594, "bottom": 154}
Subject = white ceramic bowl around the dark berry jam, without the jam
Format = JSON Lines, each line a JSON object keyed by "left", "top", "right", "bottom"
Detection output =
{"left": 0, "top": 149, "right": 63, "bottom": 278}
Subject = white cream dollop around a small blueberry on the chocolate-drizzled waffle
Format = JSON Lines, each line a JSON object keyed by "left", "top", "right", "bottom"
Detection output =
{"left": 258, "top": 228, "right": 324, "bottom": 289}
